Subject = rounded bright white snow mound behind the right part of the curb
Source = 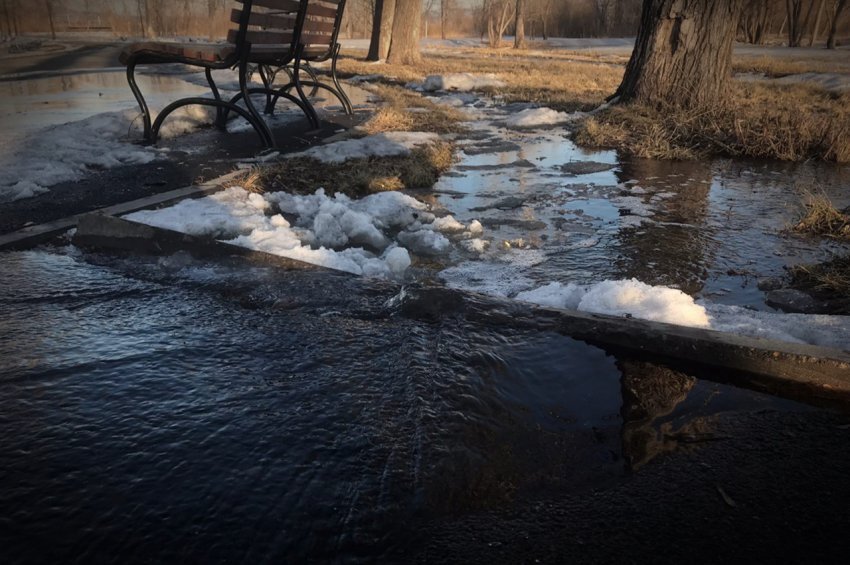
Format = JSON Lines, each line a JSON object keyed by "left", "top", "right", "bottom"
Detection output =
{"left": 516, "top": 279, "right": 710, "bottom": 328}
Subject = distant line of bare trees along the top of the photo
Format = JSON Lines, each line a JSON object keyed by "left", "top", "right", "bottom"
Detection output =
{"left": 0, "top": 0, "right": 850, "bottom": 49}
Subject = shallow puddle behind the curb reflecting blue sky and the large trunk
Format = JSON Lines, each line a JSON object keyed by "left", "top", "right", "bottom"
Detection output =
{"left": 435, "top": 107, "right": 850, "bottom": 309}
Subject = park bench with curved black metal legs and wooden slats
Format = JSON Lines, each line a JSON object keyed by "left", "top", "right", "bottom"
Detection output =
{"left": 121, "top": 0, "right": 324, "bottom": 147}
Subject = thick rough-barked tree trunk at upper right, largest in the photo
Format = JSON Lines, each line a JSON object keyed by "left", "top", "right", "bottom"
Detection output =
{"left": 615, "top": 0, "right": 743, "bottom": 107}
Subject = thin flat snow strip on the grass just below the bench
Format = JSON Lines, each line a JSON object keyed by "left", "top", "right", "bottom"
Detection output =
{"left": 287, "top": 131, "right": 440, "bottom": 163}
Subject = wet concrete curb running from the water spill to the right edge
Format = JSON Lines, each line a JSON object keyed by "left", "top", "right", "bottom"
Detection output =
{"left": 401, "top": 287, "right": 850, "bottom": 407}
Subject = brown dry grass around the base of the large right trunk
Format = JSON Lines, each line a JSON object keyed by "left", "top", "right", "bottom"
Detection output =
{"left": 576, "top": 83, "right": 850, "bottom": 163}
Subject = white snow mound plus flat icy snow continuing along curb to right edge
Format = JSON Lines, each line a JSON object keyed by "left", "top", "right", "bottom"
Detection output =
{"left": 516, "top": 279, "right": 850, "bottom": 350}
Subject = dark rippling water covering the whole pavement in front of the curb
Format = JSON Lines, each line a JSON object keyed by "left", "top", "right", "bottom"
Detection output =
{"left": 0, "top": 248, "right": 850, "bottom": 562}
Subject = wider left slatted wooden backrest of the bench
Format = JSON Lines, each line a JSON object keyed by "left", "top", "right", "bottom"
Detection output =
{"left": 227, "top": 0, "right": 312, "bottom": 54}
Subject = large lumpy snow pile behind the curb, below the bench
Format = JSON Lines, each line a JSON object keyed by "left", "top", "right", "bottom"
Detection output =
{"left": 126, "top": 187, "right": 481, "bottom": 278}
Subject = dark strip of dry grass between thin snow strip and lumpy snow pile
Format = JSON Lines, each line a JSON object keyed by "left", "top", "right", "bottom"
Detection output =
{"left": 235, "top": 142, "right": 455, "bottom": 198}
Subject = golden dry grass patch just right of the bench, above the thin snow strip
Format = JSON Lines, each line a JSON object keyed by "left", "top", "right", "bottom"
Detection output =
{"left": 359, "top": 85, "right": 468, "bottom": 134}
